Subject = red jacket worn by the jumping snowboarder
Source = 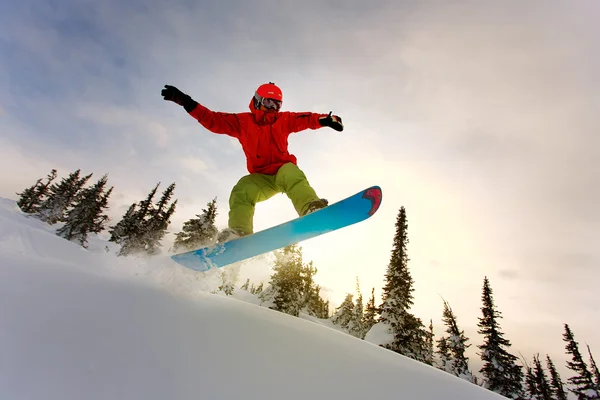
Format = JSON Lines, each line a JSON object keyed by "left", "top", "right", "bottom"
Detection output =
{"left": 190, "top": 100, "right": 327, "bottom": 175}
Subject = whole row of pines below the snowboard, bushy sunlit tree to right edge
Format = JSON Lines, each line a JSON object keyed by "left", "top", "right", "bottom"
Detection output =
{"left": 233, "top": 207, "right": 600, "bottom": 400}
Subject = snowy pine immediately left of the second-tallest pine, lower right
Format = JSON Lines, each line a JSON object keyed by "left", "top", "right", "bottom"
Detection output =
{"left": 438, "top": 300, "right": 473, "bottom": 382}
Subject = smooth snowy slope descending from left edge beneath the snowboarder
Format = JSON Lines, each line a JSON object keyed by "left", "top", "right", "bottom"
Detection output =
{"left": 0, "top": 199, "right": 502, "bottom": 400}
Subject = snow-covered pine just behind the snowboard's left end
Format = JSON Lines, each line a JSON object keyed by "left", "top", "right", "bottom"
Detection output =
{"left": 173, "top": 198, "right": 219, "bottom": 252}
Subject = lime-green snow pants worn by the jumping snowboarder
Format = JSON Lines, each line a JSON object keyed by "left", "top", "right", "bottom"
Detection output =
{"left": 229, "top": 163, "right": 319, "bottom": 235}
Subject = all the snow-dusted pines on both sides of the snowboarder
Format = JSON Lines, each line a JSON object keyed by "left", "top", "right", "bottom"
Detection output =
{"left": 17, "top": 169, "right": 600, "bottom": 400}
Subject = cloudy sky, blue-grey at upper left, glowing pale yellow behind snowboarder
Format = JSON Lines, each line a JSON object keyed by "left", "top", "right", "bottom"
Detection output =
{"left": 0, "top": 0, "right": 600, "bottom": 380}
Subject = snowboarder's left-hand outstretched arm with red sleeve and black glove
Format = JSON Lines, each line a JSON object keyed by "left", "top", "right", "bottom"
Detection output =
{"left": 161, "top": 85, "right": 240, "bottom": 138}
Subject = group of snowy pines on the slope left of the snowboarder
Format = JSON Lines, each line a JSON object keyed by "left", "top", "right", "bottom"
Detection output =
{"left": 17, "top": 169, "right": 219, "bottom": 256}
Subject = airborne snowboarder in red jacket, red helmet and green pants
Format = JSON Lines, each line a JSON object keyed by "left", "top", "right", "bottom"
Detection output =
{"left": 161, "top": 82, "right": 344, "bottom": 242}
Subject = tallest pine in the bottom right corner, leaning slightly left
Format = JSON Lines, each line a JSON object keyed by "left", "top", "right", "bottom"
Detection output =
{"left": 563, "top": 324, "right": 600, "bottom": 400}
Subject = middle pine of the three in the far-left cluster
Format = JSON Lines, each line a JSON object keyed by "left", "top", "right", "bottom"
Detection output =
{"left": 36, "top": 169, "right": 92, "bottom": 225}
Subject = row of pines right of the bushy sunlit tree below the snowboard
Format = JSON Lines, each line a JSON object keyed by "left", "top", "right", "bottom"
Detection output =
{"left": 332, "top": 207, "right": 600, "bottom": 400}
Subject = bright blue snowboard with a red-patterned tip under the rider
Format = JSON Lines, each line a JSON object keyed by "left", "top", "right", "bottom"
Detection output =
{"left": 171, "top": 186, "right": 382, "bottom": 271}
